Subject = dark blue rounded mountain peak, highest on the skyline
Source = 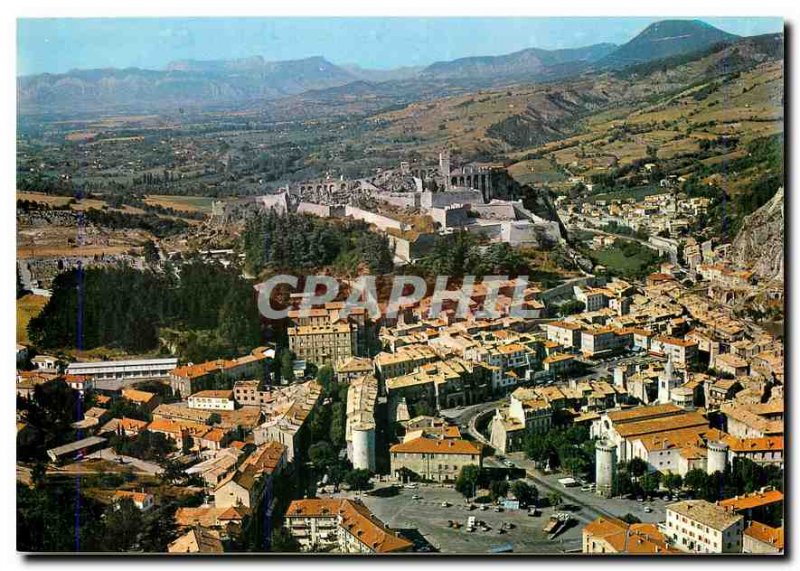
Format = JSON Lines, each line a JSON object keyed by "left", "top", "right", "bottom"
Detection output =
{"left": 598, "top": 20, "right": 739, "bottom": 67}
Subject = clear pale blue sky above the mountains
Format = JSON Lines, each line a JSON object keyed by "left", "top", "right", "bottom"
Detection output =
{"left": 17, "top": 17, "right": 783, "bottom": 75}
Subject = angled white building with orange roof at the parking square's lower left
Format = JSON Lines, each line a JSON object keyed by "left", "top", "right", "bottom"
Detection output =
{"left": 283, "top": 498, "right": 414, "bottom": 553}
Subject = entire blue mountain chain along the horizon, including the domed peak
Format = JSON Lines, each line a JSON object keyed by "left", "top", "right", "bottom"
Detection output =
{"left": 17, "top": 20, "right": 738, "bottom": 114}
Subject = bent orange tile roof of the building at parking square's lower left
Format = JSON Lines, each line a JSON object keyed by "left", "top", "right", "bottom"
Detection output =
{"left": 286, "top": 498, "right": 413, "bottom": 553}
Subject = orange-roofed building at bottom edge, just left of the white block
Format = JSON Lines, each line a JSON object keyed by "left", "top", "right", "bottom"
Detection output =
{"left": 582, "top": 516, "right": 679, "bottom": 555}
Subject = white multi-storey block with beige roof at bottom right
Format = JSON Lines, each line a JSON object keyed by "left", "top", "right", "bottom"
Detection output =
{"left": 665, "top": 500, "right": 744, "bottom": 553}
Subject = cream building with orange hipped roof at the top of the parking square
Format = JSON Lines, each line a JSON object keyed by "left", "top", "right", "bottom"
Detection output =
{"left": 389, "top": 438, "right": 482, "bottom": 482}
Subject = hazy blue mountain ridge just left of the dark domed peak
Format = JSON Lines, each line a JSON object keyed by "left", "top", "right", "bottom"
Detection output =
{"left": 422, "top": 44, "right": 617, "bottom": 80}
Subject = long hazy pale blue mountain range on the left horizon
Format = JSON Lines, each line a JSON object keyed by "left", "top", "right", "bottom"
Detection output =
{"left": 17, "top": 57, "right": 359, "bottom": 111}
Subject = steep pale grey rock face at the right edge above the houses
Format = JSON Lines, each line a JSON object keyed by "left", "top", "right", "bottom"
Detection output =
{"left": 729, "top": 187, "right": 784, "bottom": 281}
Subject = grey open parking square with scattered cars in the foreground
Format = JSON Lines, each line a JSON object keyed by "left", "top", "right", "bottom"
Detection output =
{"left": 350, "top": 485, "right": 580, "bottom": 553}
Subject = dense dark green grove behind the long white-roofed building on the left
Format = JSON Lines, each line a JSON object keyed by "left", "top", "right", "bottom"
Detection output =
{"left": 28, "top": 262, "right": 261, "bottom": 357}
